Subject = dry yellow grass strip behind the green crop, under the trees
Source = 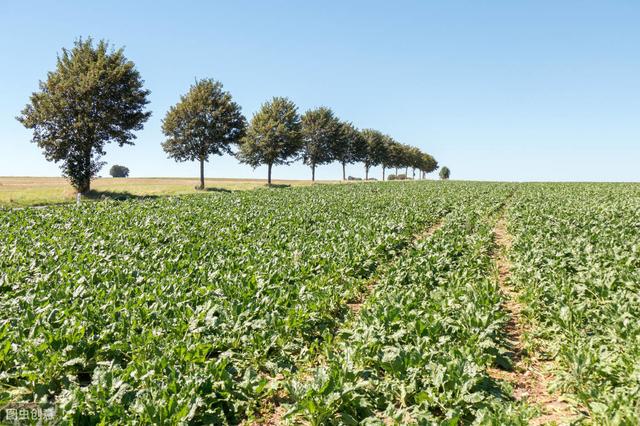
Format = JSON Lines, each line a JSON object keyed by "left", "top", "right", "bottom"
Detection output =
{"left": 0, "top": 177, "right": 338, "bottom": 207}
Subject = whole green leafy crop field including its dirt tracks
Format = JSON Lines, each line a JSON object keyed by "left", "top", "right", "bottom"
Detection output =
{"left": 0, "top": 181, "right": 640, "bottom": 425}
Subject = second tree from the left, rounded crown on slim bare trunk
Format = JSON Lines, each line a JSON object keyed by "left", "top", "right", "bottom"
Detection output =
{"left": 162, "top": 79, "right": 246, "bottom": 189}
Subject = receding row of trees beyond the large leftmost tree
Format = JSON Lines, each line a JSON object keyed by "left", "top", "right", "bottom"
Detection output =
{"left": 162, "top": 84, "right": 438, "bottom": 188}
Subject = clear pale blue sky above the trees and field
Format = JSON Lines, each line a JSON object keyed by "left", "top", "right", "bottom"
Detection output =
{"left": 0, "top": 0, "right": 640, "bottom": 181}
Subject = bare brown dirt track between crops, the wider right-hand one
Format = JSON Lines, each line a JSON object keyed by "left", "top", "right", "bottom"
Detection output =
{"left": 488, "top": 213, "right": 575, "bottom": 425}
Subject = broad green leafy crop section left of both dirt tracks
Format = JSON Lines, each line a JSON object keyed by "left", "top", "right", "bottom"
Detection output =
{"left": 0, "top": 183, "right": 460, "bottom": 423}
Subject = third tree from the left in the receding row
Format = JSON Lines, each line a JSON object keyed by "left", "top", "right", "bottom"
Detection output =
{"left": 238, "top": 97, "right": 302, "bottom": 185}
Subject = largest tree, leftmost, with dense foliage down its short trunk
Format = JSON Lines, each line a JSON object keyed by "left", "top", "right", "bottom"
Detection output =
{"left": 17, "top": 38, "right": 151, "bottom": 193}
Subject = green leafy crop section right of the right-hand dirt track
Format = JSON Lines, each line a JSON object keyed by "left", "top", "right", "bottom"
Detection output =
{"left": 509, "top": 184, "right": 640, "bottom": 425}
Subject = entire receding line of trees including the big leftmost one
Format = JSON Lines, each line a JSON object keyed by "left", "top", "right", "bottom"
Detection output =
{"left": 18, "top": 38, "right": 438, "bottom": 193}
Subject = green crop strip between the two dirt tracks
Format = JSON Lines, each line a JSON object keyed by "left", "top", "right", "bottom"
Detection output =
{"left": 278, "top": 185, "right": 533, "bottom": 425}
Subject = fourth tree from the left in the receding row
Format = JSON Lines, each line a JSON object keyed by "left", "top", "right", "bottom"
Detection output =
{"left": 301, "top": 107, "right": 340, "bottom": 181}
